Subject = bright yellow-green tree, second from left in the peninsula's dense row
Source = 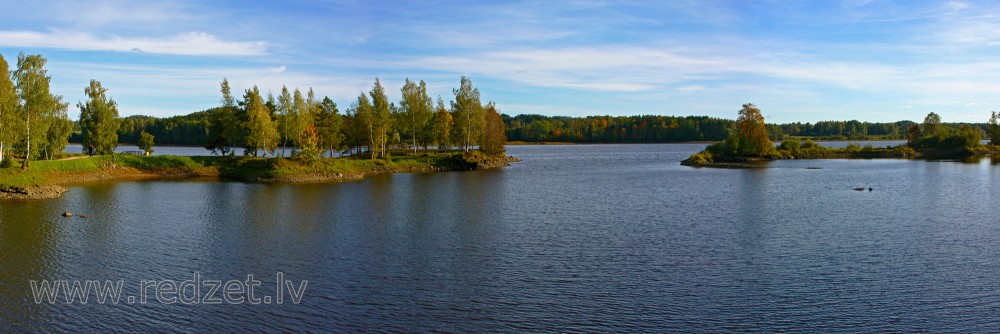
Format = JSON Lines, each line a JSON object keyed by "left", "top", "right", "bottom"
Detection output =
{"left": 243, "top": 86, "right": 280, "bottom": 156}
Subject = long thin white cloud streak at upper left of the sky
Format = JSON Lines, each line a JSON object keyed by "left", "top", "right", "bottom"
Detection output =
{"left": 0, "top": 30, "right": 267, "bottom": 56}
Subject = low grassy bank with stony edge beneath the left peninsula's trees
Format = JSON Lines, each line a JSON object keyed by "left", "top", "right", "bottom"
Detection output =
{"left": 0, "top": 152, "right": 517, "bottom": 192}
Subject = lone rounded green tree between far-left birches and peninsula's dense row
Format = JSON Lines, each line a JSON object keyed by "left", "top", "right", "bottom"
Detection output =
{"left": 77, "top": 80, "right": 121, "bottom": 154}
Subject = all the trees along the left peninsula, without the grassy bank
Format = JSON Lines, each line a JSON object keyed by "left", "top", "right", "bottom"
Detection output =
{"left": 0, "top": 52, "right": 507, "bottom": 169}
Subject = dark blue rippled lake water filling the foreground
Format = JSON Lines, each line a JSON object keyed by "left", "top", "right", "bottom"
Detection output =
{"left": 0, "top": 144, "right": 1000, "bottom": 332}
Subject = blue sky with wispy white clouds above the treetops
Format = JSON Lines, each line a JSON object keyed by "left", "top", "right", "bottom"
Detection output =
{"left": 0, "top": 0, "right": 1000, "bottom": 123}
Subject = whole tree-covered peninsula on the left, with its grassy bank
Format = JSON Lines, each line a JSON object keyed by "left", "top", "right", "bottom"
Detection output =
{"left": 0, "top": 53, "right": 517, "bottom": 199}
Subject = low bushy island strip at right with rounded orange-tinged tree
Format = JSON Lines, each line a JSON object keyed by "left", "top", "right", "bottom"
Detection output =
{"left": 681, "top": 103, "right": 1000, "bottom": 168}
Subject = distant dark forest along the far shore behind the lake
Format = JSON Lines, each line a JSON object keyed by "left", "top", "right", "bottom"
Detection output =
{"left": 82, "top": 108, "right": 987, "bottom": 146}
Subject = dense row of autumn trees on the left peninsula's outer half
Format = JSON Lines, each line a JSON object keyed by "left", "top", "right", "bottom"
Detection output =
{"left": 195, "top": 76, "right": 507, "bottom": 160}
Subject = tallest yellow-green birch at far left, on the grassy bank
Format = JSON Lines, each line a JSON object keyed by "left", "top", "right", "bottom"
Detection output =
{"left": 13, "top": 53, "right": 61, "bottom": 169}
